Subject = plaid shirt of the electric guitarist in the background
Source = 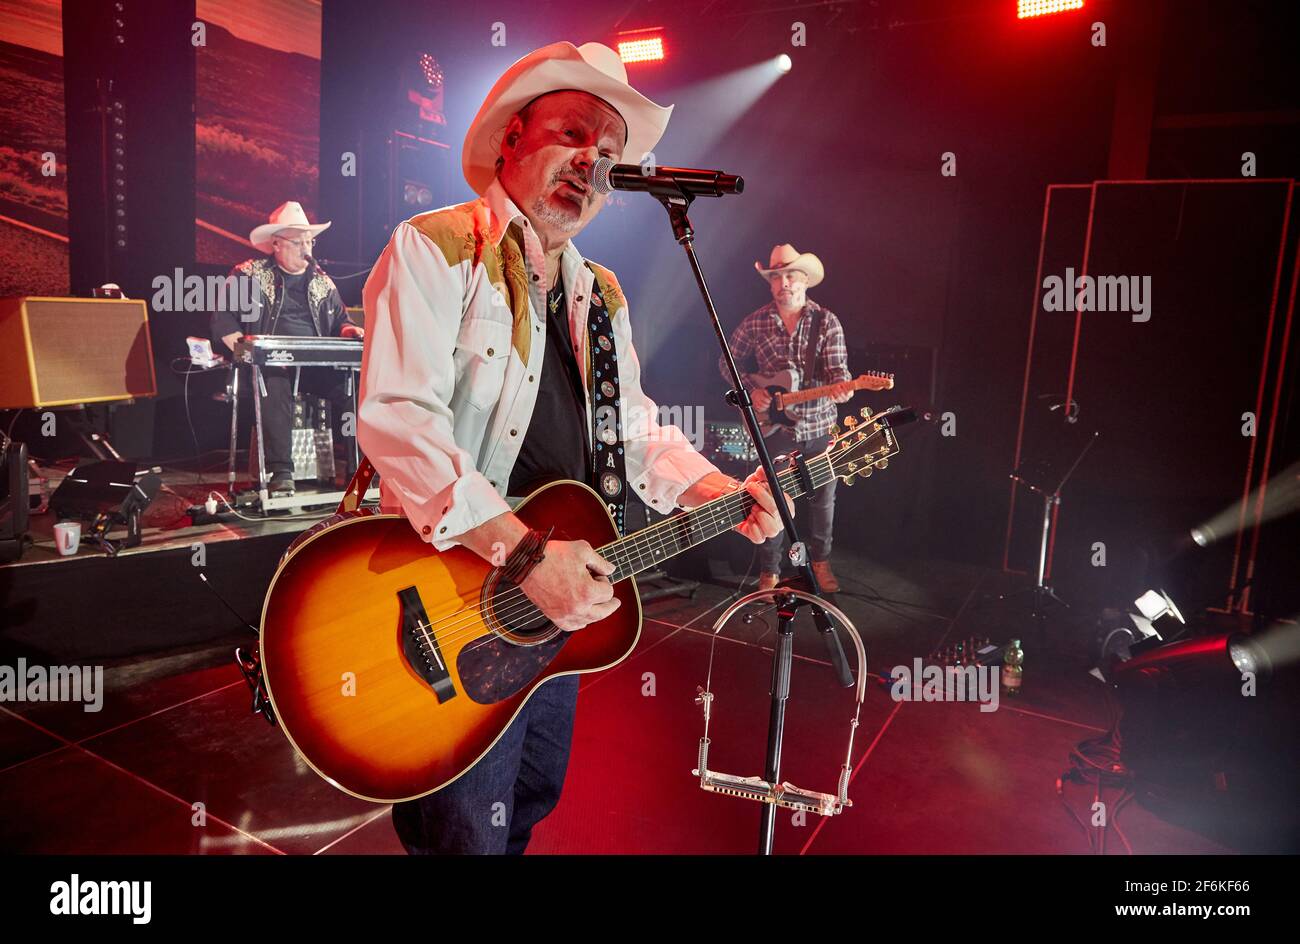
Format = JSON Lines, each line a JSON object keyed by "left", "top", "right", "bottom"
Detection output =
{"left": 718, "top": 299, "right": 853, "bottom": 442}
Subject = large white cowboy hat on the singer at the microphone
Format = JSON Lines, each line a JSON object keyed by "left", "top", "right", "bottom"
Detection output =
{"left": 460, "top": 43, "right": 672, "bottom": 195}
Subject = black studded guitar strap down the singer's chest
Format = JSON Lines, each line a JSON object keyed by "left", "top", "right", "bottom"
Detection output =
{"left": 586, "top": 276, "right": 628, "bottom": 534}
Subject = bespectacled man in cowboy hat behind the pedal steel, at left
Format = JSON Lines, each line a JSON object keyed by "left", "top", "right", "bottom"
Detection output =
{"left": 212, "top": 202, "right": 364, "bottom": 497}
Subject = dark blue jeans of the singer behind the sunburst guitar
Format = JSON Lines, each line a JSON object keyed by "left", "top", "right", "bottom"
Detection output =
{"left": 393, "top": 675, "right": 579, "bottom": 856}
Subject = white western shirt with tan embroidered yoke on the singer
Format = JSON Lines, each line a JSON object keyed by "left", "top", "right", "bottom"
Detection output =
{"left": 356, "top": 181, "right": 718, "bottom": 550}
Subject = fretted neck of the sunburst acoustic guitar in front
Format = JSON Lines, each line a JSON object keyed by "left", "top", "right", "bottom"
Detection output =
{"left": 597, "top": 454, "right": 835, "bottom": 583}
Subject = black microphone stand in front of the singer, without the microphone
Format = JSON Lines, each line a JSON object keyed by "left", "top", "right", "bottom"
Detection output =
{"left": 649, "top": 179, "right": 853, "bottom": 856}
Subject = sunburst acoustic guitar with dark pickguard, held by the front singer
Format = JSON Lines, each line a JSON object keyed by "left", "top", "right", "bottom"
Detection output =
{"left": 260, "top": 407, "right": 910, "bottom": 804}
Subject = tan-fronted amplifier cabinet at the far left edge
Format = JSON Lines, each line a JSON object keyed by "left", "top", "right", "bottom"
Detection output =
{"left": 0, "top": 296, "right": 157, "bottom": 410}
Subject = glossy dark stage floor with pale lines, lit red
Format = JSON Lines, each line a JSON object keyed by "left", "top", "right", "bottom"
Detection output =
{"left": 0, "top": 546, "right": 1279, "bottom": 854}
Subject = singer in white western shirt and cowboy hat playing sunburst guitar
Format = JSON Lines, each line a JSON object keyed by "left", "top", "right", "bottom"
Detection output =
{"left": 358, "top": 43, "right": 781, "bottom": 853}
